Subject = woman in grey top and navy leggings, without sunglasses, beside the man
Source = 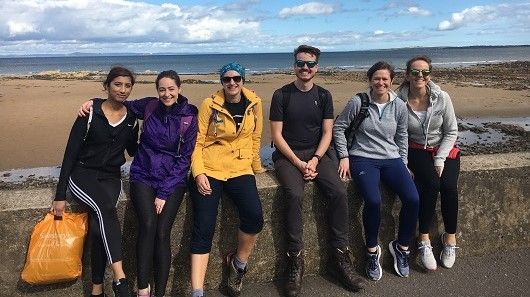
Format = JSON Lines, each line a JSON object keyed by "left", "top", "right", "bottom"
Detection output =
{"left": 333, "top": 62, "right": 419, "bottom": 281}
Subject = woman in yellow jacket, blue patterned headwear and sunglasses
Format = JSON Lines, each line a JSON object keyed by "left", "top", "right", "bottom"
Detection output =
{"left": 189, "top": 63, "right": 264, "bottom": 297}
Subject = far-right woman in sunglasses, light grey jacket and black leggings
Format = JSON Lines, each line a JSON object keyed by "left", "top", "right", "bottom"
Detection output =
{"left": 398, "top": 56, "right": 460, "bottom": 271}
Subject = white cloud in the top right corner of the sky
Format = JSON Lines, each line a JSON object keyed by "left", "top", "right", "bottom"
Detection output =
{"left": 438, "top": 3, "right": 530, "bottom": 31}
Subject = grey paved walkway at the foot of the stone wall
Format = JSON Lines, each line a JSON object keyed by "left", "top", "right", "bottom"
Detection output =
{"left": 206, "top": 249, "right": 530, "bottom": 297}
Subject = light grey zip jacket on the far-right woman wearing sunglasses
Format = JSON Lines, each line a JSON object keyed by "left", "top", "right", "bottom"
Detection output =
{"left": 398, "top": 81, "right": 458, "bottom": 166}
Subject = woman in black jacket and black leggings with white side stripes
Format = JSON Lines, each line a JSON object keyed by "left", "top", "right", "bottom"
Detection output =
{"left": 52, "top": 66, "right": 138, "bottom": 297}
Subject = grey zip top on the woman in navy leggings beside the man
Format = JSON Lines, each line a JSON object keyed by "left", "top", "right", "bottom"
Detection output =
{"left": 333, "top": 89, "right": 408, "bottom": 164}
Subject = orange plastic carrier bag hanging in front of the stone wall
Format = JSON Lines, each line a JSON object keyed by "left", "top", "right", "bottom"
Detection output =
{"left": 21, "top": 213, "right": 88, "bottom": 285}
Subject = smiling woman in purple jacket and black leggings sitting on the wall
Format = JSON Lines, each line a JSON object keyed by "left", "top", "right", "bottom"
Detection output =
{"left": 80, "top": 70, "right": 198, "bottom": 297}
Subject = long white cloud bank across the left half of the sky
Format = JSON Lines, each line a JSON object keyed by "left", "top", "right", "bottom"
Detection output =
{"left": 0, "top": 0, "right": 260, "bottom": 44}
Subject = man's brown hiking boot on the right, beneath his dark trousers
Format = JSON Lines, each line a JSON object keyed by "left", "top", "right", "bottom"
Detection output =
{"left": 329, "top": 247, "right": 363, "bottom": 292}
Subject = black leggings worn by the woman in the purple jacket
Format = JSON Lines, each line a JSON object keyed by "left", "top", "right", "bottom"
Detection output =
{"left": 130, "top": 182, "right": 186, "bottom": 296}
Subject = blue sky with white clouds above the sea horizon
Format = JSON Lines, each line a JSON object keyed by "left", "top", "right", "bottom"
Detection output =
{"left": 0, "top": 0, "right": 530, "bottom": 55}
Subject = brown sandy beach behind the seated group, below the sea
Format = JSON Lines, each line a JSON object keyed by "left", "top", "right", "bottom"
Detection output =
{"left": 0, "top": 62, "right": 530, "bottom": 170}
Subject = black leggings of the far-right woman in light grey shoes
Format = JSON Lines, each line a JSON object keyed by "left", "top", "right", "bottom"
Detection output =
{"left": 408, "top": 149, "right": 460, "bottom": 234}
